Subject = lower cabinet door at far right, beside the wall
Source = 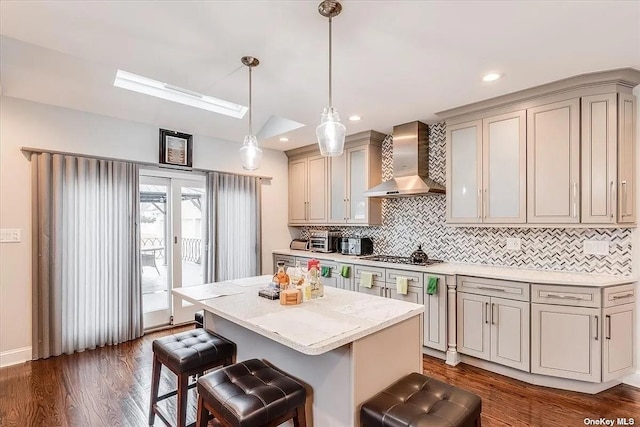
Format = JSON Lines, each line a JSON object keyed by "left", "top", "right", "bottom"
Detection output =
{"left": 602, "top": 303, "right": 636, "bottom": 381}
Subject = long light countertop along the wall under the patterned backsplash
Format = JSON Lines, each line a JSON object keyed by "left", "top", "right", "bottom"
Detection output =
{"left": 273, "top": 249, "right": 637, "bottom": 288}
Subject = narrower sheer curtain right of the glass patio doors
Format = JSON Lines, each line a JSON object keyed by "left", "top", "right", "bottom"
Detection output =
{"left": 204, "top": 172, "right": 262, "bottom": 283}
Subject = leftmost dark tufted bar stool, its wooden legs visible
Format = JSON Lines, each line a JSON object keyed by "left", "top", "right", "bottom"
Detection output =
{"left": 149, "top": 329, "right": 236, "bottom": 427}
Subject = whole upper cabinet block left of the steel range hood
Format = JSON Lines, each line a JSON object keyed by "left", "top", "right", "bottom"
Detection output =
{"left": 287, "top": 131, "right": 386, "bottom": 225}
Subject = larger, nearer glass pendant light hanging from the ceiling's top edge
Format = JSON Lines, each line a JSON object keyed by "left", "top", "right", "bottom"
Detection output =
{"left": 316, "top": 0, "right": 346, "bottom": 156}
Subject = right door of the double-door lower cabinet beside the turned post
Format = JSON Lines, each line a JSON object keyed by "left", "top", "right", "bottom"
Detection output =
{"left": 490, "top": 298, "right": 529, "bottom": 372}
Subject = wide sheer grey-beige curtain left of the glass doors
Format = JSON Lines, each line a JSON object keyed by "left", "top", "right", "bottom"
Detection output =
{"left": 31, "top": 153, "right": 142, "bottom": 359}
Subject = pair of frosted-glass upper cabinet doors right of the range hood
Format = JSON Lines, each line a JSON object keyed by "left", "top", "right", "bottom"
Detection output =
{"left": 447, "top": 111, "right": 527, "bottom": 223}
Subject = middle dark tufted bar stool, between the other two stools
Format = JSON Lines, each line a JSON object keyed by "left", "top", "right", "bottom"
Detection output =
{"left": 196, "top": 359, "right": 307, "bottom": 427}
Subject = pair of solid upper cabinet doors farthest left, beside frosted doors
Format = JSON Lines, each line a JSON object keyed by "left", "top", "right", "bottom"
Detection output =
{"left": 289, "top": 156, "right": 328, "bottom": 225}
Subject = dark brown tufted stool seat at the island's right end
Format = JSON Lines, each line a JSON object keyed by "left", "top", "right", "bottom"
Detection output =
{"left": 360, "top": 372, "right": 482, "bottom": 427}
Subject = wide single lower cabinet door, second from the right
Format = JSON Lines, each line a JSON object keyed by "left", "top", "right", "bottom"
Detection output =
{"left": 531, "top": 304, "right": 602, "bottom": 382}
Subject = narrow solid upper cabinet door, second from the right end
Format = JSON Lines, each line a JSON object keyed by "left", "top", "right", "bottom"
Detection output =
{"left": 581, "top": 93, "right": 618, "bottom": 224}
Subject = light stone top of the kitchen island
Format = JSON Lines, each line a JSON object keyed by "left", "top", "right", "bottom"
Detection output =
{"left": 172, "top": 276, "right": 424, "bottom": 355}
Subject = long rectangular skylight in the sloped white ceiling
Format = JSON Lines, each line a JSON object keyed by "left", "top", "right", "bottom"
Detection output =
{"left": 113, "top": 70, "right": 247, "bottom": 119}
